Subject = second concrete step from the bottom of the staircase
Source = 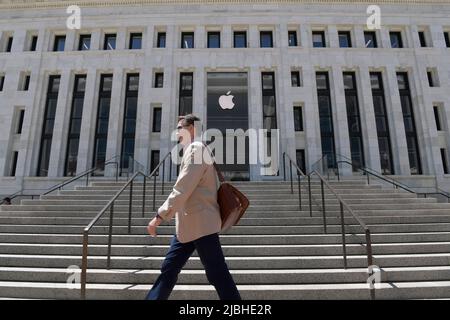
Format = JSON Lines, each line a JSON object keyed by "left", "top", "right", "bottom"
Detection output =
{"left": 0, "top": 266, "right": 450, "bottom": 285}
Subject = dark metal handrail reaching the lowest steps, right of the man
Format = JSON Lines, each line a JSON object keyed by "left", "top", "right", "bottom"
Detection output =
{"left": 308, "top": 170, "right": 375, "bottom": 299}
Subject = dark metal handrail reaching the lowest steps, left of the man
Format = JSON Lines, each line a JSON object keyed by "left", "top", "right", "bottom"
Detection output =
{"left": 81, "top": 152, "right": 172, "bottom": 299}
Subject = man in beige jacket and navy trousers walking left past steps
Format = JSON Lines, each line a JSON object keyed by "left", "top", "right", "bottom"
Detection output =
{"left": 147, "top": 114, "right": 241, "bottom": 300}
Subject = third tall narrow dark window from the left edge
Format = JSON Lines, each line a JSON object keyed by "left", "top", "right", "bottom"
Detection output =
{"left": 93, "top": 74, "right": 113, "bottom": 175}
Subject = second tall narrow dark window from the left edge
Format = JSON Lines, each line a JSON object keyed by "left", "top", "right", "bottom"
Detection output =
{"left": 64, "top": 75, "right": 86, "bottom": 176}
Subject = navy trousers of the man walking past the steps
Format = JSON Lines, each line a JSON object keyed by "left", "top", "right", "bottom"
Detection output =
{"left": 146, "top": 233, "right": 241, "bottom": 300}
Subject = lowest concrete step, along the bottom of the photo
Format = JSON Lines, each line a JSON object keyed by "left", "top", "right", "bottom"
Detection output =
{"left": 0, "top": 281, "right": 450, "bottom": 300}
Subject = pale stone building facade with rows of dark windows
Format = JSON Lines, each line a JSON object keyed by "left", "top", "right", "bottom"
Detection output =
{"left": 0, "top": 0, "right": 450, "bottom": 194}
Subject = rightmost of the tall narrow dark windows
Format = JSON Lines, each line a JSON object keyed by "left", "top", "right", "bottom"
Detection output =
{"left": 397, "top": 72, "right": 422, "bottom": 174}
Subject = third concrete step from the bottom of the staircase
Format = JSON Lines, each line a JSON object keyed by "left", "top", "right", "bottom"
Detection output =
{"left": 0, "top": 253, "right": 450, "bottom": 270}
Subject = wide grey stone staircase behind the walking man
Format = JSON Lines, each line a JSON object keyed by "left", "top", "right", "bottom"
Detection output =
{"left": 0, "top": 180, "right": 450, "bottom": 299}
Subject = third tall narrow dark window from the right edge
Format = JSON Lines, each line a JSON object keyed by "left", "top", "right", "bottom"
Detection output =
{"left": 343, "top": 72, "right": 365, "bottom": 171}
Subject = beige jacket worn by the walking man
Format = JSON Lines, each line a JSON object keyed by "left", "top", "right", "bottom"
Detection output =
{"left": 158, "top": 141, "right": 222, "bottom": 243}
